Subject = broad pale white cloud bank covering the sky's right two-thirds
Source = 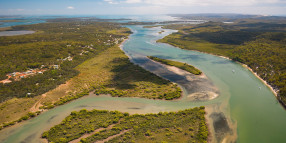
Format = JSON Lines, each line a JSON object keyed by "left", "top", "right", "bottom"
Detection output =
{"left": 102, "top": 0, "right": 286, "bottom": 15}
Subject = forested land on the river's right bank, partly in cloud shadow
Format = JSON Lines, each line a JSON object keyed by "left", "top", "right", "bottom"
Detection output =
{"left": 158, "top": 19, "right": 286, "bottom": 107}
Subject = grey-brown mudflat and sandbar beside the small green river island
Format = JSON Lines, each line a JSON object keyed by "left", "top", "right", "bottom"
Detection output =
{"left": 133, "top": 54, "right": 219, "bottom": 101}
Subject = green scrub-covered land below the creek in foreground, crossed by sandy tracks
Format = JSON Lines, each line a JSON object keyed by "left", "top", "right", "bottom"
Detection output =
{"left": 42, "top": 107, "right": 208, "bottom": 143}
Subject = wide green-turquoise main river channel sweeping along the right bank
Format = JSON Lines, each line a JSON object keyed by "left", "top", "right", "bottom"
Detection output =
{"left": 124, "top": 26, "right": 286, "bottom": 143}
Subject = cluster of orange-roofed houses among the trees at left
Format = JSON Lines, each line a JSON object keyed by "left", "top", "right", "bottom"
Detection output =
{"left": 0, "top": 65, "right": 59, "bottom": 84}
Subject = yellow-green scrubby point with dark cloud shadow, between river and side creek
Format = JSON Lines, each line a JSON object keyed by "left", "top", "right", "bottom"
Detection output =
{"left": 0, "top": 35, "right": 182, "bottom": 128}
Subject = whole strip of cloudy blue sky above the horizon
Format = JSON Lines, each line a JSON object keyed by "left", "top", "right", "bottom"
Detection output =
{"left": 0, "top": 0, "right": 286, "bottom": 15}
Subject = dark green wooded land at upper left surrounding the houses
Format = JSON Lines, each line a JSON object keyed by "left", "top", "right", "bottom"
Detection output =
{"left": 0, "top": 22, "right": 128, "bottom": 102}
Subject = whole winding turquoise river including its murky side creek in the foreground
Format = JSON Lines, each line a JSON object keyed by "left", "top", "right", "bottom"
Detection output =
{"left": 0, "top": 26, "right": 286, "bottom": 143}
